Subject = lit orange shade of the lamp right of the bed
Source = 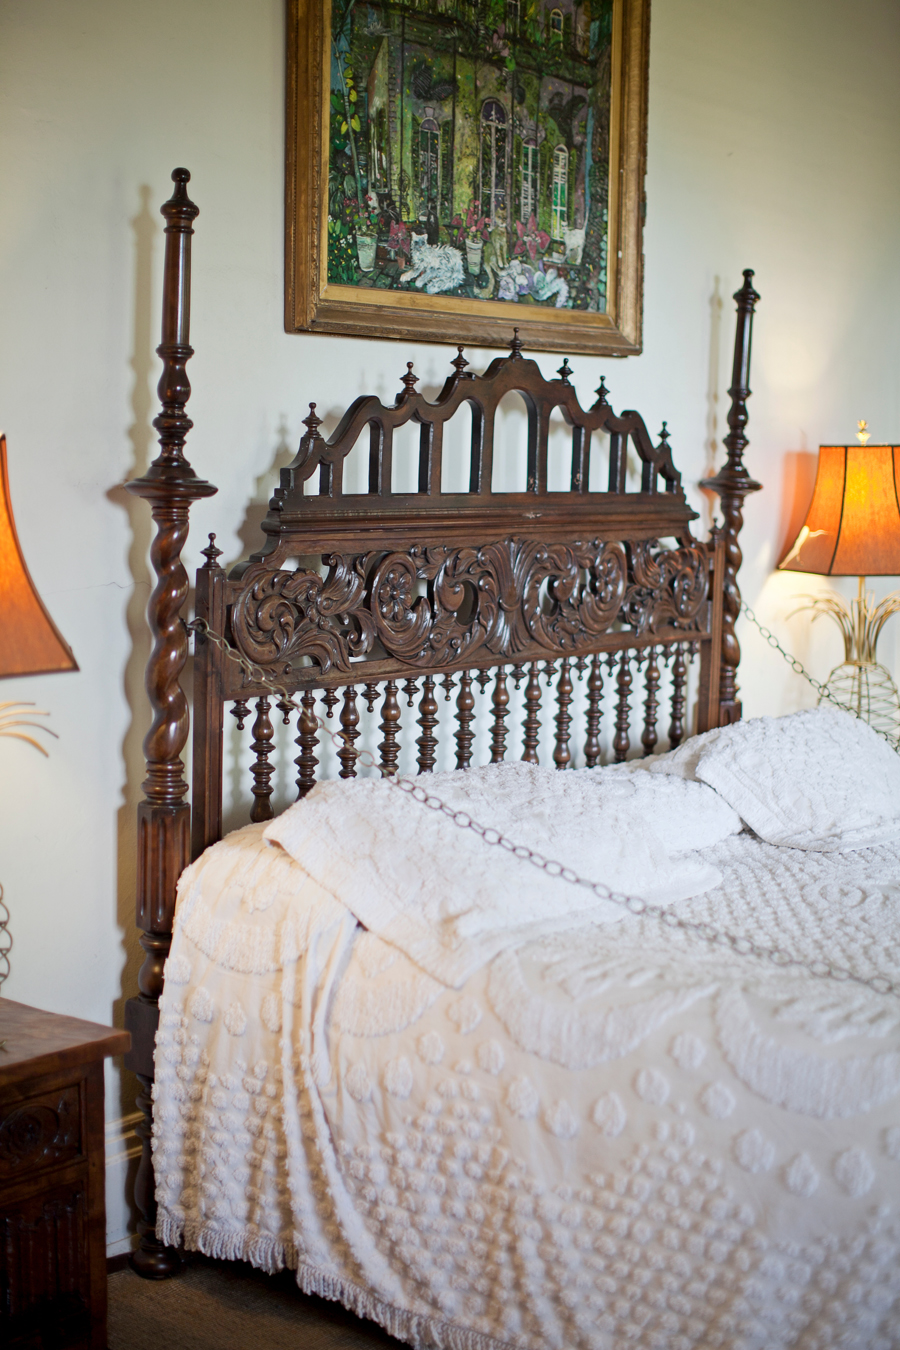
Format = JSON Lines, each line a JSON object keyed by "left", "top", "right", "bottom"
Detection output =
{"left": 779, "top": 446, "right": 900, "bottom": 576}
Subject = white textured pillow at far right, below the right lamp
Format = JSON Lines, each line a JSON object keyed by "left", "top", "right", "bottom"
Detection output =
{"left": 654, "top": 707, "right": 900, "bottom": 853}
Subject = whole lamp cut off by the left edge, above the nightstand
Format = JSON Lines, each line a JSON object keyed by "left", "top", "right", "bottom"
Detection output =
{"left": 0, "top": 432, "right": 78, "bottom": 984}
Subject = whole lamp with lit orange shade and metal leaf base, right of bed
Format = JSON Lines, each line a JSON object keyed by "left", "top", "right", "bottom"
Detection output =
{"left": 779, "top": 421, "right": 900, "bottom": 743}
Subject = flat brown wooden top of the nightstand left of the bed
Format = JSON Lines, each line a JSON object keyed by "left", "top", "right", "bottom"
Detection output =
{"left": 0, "top": 998, "right": 131, "bottom": 1089}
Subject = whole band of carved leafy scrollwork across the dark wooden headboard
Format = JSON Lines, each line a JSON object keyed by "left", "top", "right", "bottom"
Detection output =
{"left": 232, "top": 539, "right": 708, "bottom": 672}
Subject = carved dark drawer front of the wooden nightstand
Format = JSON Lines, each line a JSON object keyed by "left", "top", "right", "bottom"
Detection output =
{"left": 0, "top": 1083, "right": 82, "bottom": 1181}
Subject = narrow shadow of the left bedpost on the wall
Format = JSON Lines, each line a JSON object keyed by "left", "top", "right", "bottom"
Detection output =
{"left": 107, "top": 186, "right": 159, "bottom": 1218}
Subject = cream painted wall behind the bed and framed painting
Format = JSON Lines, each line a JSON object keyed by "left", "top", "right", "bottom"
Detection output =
{"left": 0, "top": 0, "right": 900, "bottom": 1250}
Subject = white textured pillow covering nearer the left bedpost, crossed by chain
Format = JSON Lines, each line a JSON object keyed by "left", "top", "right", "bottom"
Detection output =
{"left": 266, "top": 763, "right": 739, "bottom": 988}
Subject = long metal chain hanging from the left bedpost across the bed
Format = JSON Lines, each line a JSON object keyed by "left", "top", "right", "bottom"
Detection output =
{"left": 185, "top": 612, "right": 900, "bottom": 998}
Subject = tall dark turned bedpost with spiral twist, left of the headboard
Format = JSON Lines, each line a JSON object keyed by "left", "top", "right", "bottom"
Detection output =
{"left": 125, "top": 169, "right": 216, "bottom": 1280}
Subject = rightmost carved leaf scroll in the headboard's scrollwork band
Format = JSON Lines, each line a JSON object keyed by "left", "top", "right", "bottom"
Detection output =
{"left": 619, "top": 540, "right": 710, "bottom": 636}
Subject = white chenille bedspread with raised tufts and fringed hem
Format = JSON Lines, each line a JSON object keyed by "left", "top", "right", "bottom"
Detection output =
{"left": 154, "top": 788, "right": 900, "bottom": 1350}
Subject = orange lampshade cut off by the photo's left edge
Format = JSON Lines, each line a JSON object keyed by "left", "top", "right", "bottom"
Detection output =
{"left": 0, "top": 436, "right": 78, "bottom": 678}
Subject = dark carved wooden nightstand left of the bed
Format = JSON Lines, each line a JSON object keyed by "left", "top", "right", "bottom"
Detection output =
{"left": 0, "top": 999, "right": 131, "bottom": 1350}
